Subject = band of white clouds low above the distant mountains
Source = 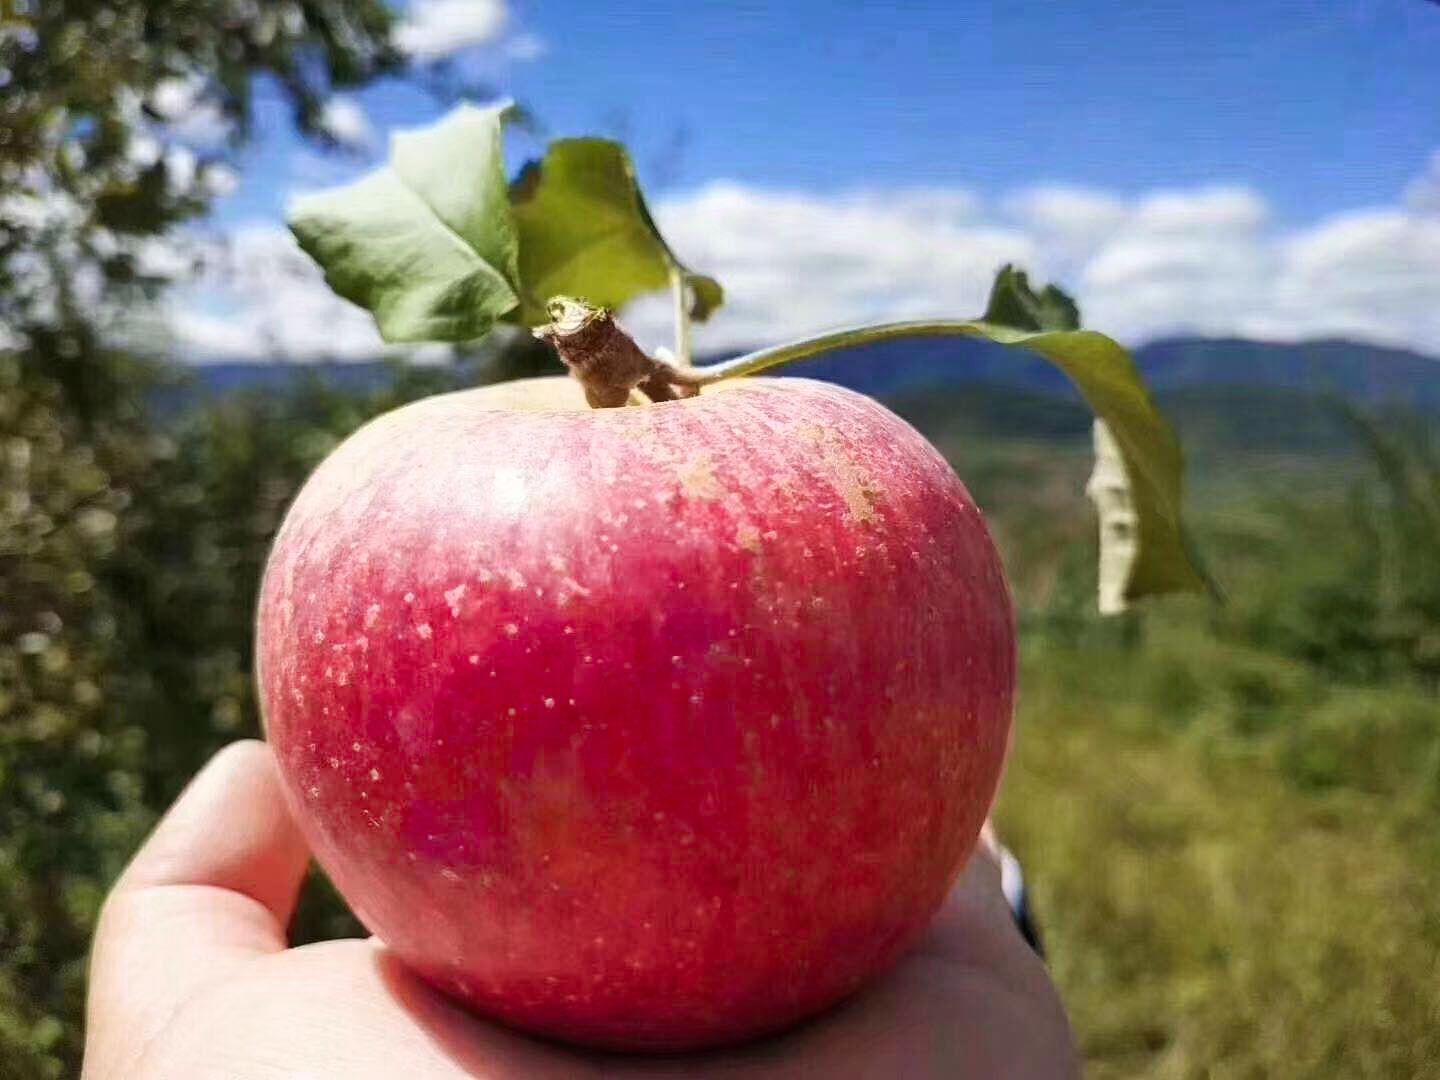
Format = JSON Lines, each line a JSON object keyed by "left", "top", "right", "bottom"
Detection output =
{"left": 163, "top": 154, "right": 1440, "bottom": 359}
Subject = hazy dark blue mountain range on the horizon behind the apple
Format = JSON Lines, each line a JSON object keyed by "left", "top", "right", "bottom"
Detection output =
{"left": 181, "top": 337, "right": 1440, "bottom": 452}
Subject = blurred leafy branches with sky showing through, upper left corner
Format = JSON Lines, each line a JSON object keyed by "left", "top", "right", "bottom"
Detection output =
{"left": 0, "top": 0, "right": 402, "bottom": 348}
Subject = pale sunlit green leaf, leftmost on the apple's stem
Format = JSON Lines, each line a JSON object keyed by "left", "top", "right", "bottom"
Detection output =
{"left": 289, "top": 105, "right": 520, "bottom": 341}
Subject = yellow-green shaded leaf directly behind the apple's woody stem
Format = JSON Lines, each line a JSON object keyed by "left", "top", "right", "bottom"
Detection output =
{"left": 511, "top": 138, "right": 724, "bottom": 325}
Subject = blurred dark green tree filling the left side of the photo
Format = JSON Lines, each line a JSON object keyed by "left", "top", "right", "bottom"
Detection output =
{"left": 0, "top": 0, "right": 403, "bottom": 1080}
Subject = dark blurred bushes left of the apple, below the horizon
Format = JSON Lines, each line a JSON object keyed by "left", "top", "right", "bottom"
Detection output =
{"left": 0, "top": 359, "right": 455, "bottom": 1077}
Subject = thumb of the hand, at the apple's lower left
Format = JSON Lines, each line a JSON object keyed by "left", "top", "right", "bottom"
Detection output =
{"left": 85, "top": 740, "right": 310, "bottom": 1080}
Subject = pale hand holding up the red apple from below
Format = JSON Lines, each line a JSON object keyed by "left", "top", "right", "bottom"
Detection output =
{"left": 84, "top": 742, "right": 1077, "bottom": 1080}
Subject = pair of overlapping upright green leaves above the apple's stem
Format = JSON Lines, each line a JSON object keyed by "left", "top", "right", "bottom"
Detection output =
{"left": 289, "top": 105, "right": 723, "bottom": 341}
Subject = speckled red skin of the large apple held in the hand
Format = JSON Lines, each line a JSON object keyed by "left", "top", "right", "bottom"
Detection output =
{"left": 258, "top": 379, "right": 1015, "bottom": 1050}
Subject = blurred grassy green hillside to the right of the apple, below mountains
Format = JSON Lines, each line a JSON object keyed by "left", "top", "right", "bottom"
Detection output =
{"left": 901, "top": 397, "right": 1440, "bottom": 1079}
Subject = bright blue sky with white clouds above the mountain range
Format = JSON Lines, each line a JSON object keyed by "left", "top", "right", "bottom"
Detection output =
{"left": 177, "top": 0, "right": 1440, "bottom": 364}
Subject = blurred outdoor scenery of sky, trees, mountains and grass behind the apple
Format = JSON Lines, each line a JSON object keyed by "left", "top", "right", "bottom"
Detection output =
{"left": 0, "top": 0, "right": 1440, "bottom": 1080}
